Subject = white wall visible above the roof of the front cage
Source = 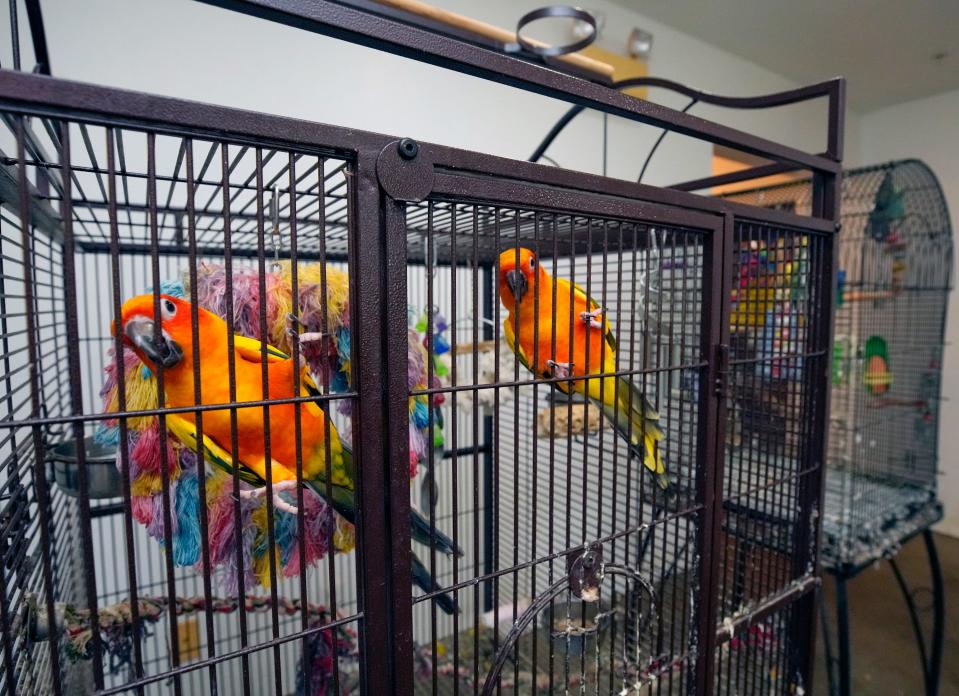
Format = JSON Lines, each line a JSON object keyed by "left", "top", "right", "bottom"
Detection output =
{"left": 0, "top": 0, "right": 858, "bottom": 184}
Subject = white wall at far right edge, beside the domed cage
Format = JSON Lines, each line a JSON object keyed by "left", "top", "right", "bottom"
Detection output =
{"left": 861, "top": 90, "right": 959, "bottom": 536}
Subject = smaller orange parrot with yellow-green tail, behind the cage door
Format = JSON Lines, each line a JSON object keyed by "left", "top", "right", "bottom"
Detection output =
{"left": 499, "top": 248, "right": 672, "bottom": 492}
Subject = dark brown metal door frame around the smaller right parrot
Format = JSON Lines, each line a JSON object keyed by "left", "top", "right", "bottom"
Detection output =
{"left": 378, "top": 155, "right": 732, "bottom": 693}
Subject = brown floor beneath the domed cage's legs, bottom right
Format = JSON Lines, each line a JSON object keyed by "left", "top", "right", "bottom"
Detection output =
{"left": 813, "top": 535, "right": 959, "bottom": 696}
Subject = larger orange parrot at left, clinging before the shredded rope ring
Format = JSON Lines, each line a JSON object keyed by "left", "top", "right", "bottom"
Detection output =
{"left": 114, "top": 294, "right": 463, "bottom": 614}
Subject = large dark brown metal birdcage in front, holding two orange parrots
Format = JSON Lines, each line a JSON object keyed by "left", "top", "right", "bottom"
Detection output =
{"left": 0, "top": 0, "right": 843, "bottom": 694}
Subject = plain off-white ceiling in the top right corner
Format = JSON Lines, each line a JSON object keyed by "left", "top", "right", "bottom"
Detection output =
{"left": 613, "top": 0, "right": 959, "bottom": 111}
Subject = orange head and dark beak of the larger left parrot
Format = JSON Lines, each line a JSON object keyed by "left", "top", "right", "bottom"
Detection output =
{"left": 113, "top": 294, "right": 202, "bottom": 371}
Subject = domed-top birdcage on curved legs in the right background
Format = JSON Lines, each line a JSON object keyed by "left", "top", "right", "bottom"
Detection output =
{"left": 731, "top": 160, "right": 953, "bottom": 693}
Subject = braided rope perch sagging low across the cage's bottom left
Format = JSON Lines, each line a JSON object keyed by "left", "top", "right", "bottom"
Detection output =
{"left": 50, "top": 595, "right": 359, "bottom": 696}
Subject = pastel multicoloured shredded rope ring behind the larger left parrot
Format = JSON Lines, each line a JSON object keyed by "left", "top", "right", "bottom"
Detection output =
{"left": 97, "top": 262, "right": 442, "bottom": 594}
